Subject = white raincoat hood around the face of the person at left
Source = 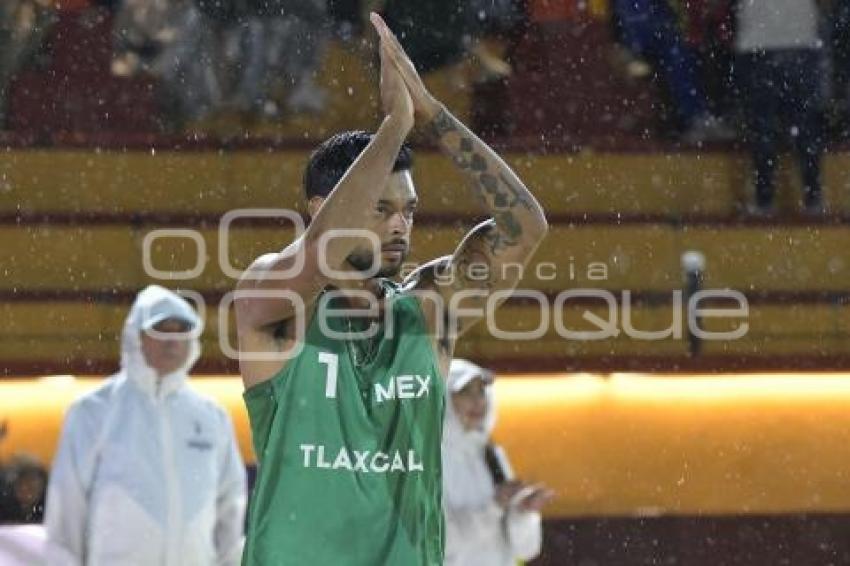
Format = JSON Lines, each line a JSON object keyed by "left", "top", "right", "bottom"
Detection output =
{"left": 121, "top": 285, "right": 203, "bottom": 395}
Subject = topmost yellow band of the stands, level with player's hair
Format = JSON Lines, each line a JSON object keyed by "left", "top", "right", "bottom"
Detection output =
{"left": 0, "top": 149, "right": 850, "bottom": 217}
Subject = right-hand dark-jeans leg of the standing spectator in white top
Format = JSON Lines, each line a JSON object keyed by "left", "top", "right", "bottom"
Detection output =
{"left": 776, "top": 49, "right": 824, "bottom": 214}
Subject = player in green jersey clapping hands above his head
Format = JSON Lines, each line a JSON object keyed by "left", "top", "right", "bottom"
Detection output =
{"left": 235, "top": 14, "right": 548, "bottom": 566}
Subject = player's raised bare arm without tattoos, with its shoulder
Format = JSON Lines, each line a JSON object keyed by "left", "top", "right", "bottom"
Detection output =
{"left": 235, "top": 27, "right": 413, "bottom": 329}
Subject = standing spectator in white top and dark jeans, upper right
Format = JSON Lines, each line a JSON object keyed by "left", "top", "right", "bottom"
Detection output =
{"left": 735, "top": 0, "right": 824, "bottom": 215}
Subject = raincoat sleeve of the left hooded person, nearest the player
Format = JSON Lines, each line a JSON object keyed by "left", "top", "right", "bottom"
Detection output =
{"left": 214, "top": 410, "right": 247, "bottom": 566}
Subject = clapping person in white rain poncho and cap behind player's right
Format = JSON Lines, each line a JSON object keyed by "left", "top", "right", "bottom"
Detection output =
{"left": 443, "top": 359, "right": 552, "bottom": 566}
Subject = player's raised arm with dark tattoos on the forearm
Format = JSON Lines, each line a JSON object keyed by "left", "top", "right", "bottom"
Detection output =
{"left": 373, "top": 16, "right": 548, "bottom": 338}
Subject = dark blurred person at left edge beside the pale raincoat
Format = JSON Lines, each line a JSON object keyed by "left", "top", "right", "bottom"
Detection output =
{"left": 0, "top": 454, "right": 47, "bottom": 523}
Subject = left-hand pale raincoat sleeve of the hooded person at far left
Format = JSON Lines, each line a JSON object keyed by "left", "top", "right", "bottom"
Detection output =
{"left": 44, "top": 404, "right": 97, "bottom": 566}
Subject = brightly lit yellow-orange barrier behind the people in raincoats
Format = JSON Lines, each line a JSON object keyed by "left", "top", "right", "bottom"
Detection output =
{"left": 0, "top": 374, "right": 850, "bottom": 517}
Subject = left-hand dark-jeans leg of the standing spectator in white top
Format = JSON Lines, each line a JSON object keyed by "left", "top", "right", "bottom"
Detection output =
{"left": 735, "top": 52, "right": 780, "bottom": 214}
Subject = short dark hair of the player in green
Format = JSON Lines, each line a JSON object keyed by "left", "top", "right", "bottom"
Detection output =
{"left": 304, "top": 130, "right": 413, "bottom": 200}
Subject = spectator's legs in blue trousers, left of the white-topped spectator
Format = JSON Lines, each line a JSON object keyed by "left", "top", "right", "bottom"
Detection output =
{"left": 611, "top": 0, "right": 734, "bottom": 143}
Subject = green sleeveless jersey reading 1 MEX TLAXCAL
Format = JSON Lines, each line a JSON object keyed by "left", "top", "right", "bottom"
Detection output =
{"left": 242, "top": 281, "right": 445, "bottom": 566}
